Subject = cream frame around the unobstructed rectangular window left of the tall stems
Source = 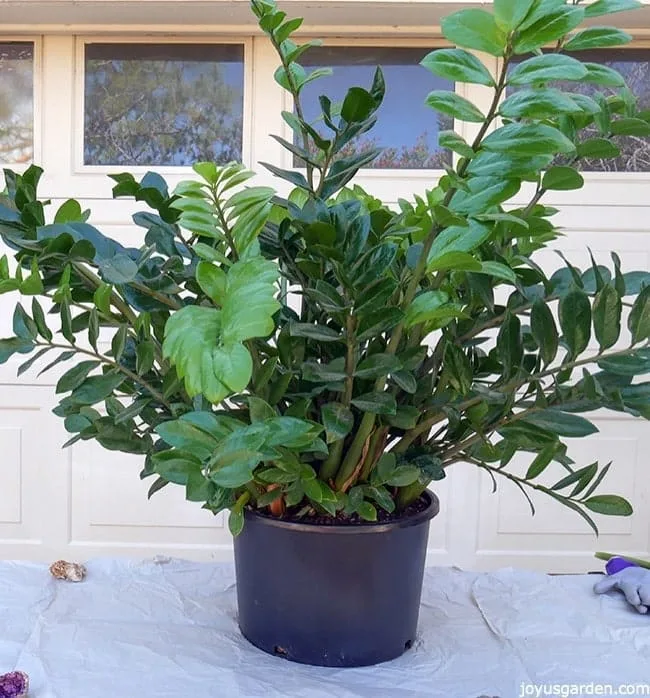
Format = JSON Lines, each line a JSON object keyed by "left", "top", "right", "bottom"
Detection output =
{"left": 70, "top": 33, "right": 254, "bottom": 180}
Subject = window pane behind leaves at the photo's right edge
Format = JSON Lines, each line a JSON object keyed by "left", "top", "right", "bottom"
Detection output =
{"left": 508, "top": 49, "right": 650, "bottom": 172}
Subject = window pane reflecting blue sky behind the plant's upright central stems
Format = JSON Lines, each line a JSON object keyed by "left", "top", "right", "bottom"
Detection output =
{"left": 296, "top": 46, "right": 454, "bottom": 169}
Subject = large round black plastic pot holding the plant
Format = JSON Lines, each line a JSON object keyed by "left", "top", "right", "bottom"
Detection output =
{"left": 230, "top": 492, "right": 439, "bottom": 667}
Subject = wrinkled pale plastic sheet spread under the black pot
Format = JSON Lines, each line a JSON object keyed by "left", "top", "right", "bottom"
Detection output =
{"left": 0, "top": 559, "right": 650, "bottom": 698}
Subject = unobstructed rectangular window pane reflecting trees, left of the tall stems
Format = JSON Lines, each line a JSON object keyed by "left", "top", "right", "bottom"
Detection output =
{"left": 84, "top": 43, "right": 244, "bottom": 166}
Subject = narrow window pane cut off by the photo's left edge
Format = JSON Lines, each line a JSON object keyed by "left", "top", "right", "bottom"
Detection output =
{"left": 0, "top": 41, "right": 34, "bottom": 164}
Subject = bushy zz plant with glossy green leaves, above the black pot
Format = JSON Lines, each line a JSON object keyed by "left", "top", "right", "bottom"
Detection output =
{"left": 0, "top": 0, "right": 650, "bottom": 534}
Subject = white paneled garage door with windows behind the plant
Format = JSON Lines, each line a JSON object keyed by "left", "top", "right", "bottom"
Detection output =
{"left": 0, "top": 14, "right": 650, "bottom": 571}
